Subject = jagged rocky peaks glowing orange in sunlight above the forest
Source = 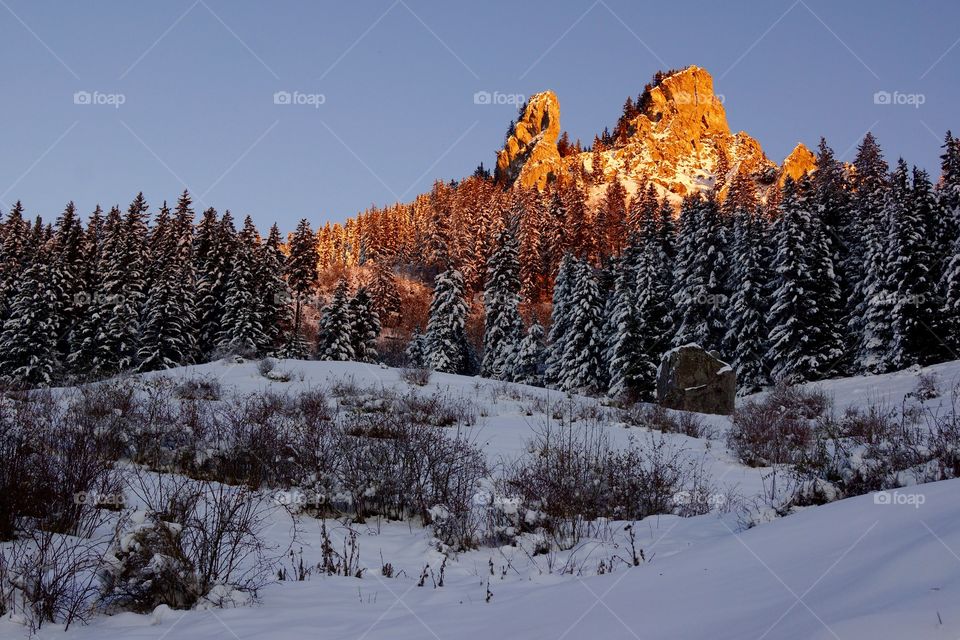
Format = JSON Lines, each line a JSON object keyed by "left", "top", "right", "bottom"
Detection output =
{"left": 497, "top": 66, "right": 815, "bottom": 200}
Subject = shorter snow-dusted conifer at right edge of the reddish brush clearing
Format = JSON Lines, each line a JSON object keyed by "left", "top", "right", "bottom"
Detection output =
{"left": 424, "top": 269, "right": 474, "bottom": 374}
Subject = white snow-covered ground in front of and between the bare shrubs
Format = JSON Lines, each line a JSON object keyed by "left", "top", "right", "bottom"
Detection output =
{"left": 7, "top": 361, "right": 960, "bottom": 640}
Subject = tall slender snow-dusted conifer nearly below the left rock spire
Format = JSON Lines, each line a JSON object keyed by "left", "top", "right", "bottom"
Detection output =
{"left": 481, "top": 226, "right": 523, "bottom": 380}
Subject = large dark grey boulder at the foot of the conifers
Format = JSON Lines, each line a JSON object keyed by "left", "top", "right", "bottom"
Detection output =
{"left": 657, "top": 344, "right": 737, "bottom": 415}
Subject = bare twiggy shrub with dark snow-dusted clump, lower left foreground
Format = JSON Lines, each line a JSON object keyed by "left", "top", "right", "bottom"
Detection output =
{"left": 103, "top": 470, "right": 295, "bottom": 611}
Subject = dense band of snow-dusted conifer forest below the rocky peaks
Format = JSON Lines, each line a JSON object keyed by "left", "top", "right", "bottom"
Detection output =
{"left": 0, "top": 133, "right": 960, "bottom": 398}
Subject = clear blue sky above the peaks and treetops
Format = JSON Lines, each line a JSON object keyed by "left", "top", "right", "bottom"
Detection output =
{"left": 0, "top": 0, "right": 960, "bottom": 230}
